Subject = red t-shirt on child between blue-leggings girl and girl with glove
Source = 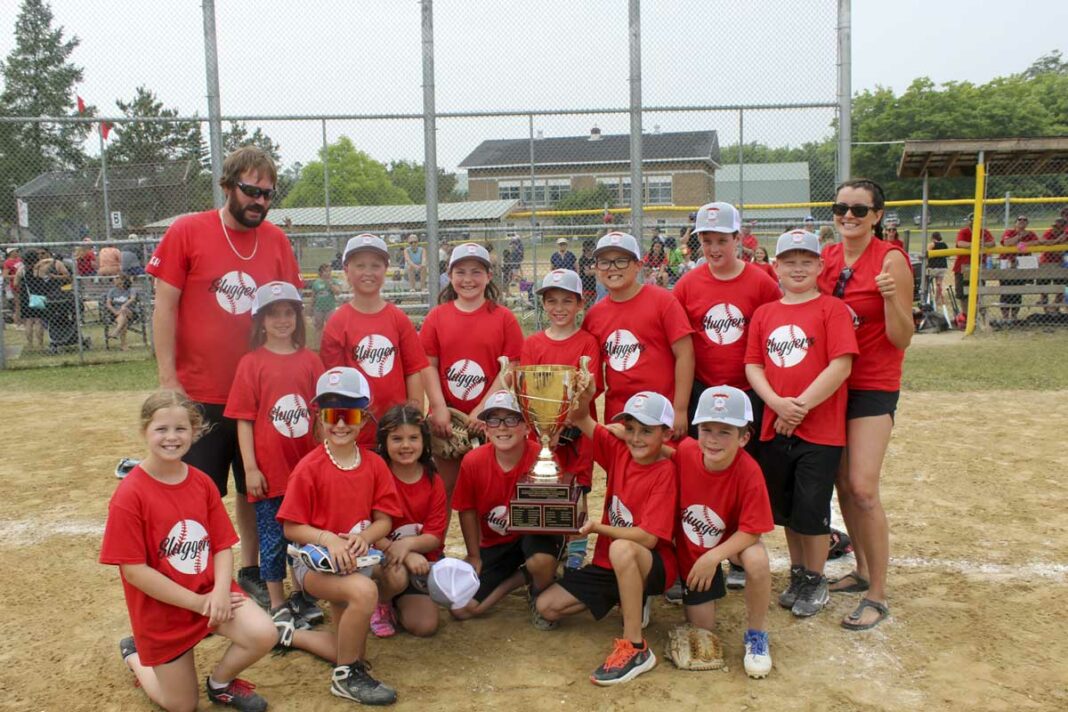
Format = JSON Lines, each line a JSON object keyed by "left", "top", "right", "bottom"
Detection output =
{"left": 319, "top": 303, "right": 429, "bottom": 447}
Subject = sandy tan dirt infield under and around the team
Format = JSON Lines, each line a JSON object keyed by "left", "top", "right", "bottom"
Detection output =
{"left": 0, "top": 392, "right": 1068, "bottom": 711}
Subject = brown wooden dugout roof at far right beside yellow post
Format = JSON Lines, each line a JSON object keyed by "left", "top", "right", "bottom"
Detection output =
{"left": 897, "top": 137, "right": 1068, "bottom": 178}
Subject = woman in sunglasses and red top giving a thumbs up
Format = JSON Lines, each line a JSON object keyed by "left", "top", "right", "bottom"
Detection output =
{"left": 819, "top": 180, "right": 914, "bottom": 630}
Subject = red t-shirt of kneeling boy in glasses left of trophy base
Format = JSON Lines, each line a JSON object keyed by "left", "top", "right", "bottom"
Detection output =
{"left": 453, "top": 440, "right": 539, "bottom": 549}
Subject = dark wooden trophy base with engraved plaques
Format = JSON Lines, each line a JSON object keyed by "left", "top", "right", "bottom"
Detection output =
{"left": 507, "top": 473, "right": 586, "bottom": 534}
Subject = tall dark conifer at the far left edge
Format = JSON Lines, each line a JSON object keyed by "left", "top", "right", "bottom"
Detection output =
{"left": 0, "top": 0, "right": 92, "bottom": 219}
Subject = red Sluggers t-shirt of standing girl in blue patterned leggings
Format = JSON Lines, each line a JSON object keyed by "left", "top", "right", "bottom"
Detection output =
{"left": 223, "top": 347, "right": 325, "bottom": 502}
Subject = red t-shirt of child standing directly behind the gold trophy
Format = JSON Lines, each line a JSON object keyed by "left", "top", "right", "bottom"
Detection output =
{"left": 519, "top": 329, "right": 604, "bottom": 487}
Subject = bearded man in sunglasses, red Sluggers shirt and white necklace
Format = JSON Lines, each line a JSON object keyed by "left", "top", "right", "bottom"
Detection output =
{"left": 145, "top": 145, "right": 302, "bottom": 606}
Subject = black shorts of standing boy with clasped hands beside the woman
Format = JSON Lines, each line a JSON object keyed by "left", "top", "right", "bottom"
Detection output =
{"left": 760, "top": 433, "right": 843, "bottom": 536}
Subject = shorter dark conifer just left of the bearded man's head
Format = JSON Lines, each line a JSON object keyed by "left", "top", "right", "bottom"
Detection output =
{"left": 107, "top": 86, "right": 203, "bottom": 163}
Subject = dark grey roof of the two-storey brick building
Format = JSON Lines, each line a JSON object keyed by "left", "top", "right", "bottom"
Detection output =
{"left": 459, "top": 131, "right": 720, "bottom": 169}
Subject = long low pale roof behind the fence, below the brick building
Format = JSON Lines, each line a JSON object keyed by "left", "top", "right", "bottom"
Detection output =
{"left": 145, "top": 200, "right": 519, "bottom": 230}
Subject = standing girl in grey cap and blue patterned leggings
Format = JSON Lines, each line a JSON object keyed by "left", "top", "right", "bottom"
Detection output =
{"left": 223, "top": 282, "right": 323, "bottom": 626}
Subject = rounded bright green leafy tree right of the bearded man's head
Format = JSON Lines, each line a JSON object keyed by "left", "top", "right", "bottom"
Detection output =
{"left": 283, "top": 136, "right": 412, "bottom": 208}
